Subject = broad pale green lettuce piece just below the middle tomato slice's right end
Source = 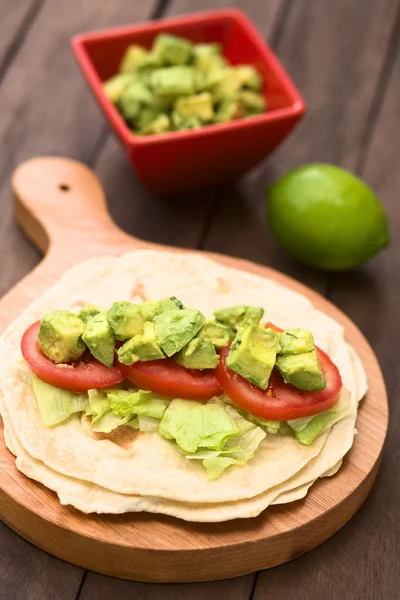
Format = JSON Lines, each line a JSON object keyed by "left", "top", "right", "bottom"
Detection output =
{"left": 158, "top": 399, "right": 241, "bottom": 453}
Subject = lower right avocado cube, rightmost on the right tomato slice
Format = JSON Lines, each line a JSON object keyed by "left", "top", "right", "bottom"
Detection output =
{"left": 276, "top": 350, "right": 326, "bottom": 391}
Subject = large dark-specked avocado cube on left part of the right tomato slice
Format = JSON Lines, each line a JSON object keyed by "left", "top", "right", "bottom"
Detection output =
{"left": 226, "top": 321, "right": 279, "bottom": 390}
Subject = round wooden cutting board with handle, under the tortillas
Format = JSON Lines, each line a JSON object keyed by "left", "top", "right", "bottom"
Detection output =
{"left": 0, "top": 158, "right": 388, "bottom": 582}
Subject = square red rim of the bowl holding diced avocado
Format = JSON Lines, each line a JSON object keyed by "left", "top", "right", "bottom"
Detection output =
{"left": 71, "top": 8, "right": 306, "bottom": 146}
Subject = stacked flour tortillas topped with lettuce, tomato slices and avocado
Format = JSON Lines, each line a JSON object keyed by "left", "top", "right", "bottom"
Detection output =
{"left": 0, "top": 251, "right": 366, "bottom": 522}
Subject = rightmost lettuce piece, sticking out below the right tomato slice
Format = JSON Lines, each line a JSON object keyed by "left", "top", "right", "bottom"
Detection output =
{"left": 287, "top": 390, "right": 351, "bottom": 446}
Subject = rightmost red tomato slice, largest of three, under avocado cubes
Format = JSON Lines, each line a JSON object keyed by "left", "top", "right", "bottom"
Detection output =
{"left": 216, "top": 340, "right": 342, "bottom": 421}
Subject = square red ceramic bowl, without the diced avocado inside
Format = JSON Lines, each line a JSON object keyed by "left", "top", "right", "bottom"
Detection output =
{"left": 72, "top": 9, "right": 305, "bottom": 193}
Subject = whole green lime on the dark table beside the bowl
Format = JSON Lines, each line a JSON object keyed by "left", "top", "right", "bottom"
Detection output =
{"left": 267, "top": 163, "right": 389, "bottom": 271}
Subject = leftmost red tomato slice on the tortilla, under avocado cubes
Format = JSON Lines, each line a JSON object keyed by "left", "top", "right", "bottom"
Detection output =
{"left": 21, "top": 321, "right": 124, "bottom": 392}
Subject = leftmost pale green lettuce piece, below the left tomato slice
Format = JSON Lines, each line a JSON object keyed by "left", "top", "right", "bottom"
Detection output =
{"left": 32, "top": 375, "right": 88, "bottom": 427}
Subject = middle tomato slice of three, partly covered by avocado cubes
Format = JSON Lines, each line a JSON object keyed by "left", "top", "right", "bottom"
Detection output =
{"left": 118, "top": 358, "right": 222, "bottom": 400}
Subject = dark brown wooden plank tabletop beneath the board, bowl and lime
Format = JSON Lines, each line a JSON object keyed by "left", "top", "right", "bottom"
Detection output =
{"left": 0, "top": 0, "right": 400, "bottom": 600}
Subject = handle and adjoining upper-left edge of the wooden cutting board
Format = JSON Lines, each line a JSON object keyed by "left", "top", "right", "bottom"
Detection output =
{"left": 0, "top": 157, "right": 148, "bottom": 330}
